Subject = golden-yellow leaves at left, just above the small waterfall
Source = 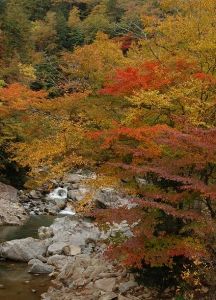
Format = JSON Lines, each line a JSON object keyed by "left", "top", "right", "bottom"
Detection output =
{"left": 10, "top": 121, "right": 88, "bottom": 188}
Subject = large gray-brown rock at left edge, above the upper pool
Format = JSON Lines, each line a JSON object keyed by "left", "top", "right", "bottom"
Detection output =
{"left": 0, "top": 183, "right": 27, "bottom": 225}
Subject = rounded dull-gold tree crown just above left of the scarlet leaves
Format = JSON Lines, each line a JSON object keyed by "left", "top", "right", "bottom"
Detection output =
{"left": 60, "top": 33, "right": 127, "bottom": 89}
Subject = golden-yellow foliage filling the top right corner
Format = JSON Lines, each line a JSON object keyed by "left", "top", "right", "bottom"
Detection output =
{"left": 137, "top": 0, "right": 216, "bottom": 73}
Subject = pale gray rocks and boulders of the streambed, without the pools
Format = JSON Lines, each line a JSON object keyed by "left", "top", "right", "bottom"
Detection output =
{"left": 0, "top": 170, "right": 172, "bottom": 300}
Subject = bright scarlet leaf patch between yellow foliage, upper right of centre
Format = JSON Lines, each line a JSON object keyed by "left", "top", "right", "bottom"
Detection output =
{"left": 99, "top": 59, "right": 196, "bottom": 96}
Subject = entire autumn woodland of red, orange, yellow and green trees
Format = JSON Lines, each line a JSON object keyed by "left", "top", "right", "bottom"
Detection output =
{"left": 0, "top": 0, "right": 216, "bottom": 299}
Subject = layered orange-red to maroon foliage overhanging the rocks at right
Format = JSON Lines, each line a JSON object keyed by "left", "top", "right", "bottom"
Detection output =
{"left": 91, "top": 120, "right": 216, "bottom": 268}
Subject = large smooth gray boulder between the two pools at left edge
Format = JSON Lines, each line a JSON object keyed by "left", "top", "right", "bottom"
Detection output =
{"left": 0, "top": 237, "right": 50, "bottom": 262}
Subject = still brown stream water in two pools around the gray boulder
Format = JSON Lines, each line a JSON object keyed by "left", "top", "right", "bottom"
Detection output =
{"left": 0, "top": 216, "right": 55, "bottom": 300}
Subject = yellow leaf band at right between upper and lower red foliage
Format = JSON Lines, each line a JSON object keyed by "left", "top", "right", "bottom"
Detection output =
{"left": 121, "top": 76, "right": 216, "bottom": 127}
